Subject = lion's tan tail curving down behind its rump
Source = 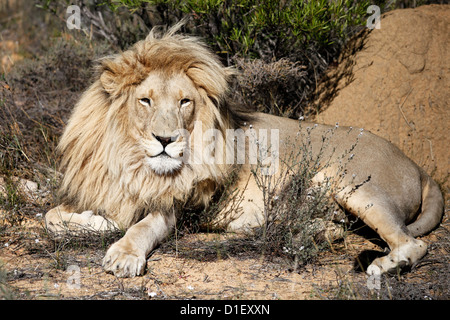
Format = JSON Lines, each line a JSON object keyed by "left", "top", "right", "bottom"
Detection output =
{"left": 407, "top": 171, "right": 444, "bottom": 237}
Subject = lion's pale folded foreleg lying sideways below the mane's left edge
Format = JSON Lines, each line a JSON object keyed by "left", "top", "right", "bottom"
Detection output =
{"left": 45, "top": 205, "right": 118, "bottom": 234}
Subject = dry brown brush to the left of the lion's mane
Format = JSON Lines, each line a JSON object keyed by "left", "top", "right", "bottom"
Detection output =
{"left": 0, "top": 35, "right": 113, "bottom": 220}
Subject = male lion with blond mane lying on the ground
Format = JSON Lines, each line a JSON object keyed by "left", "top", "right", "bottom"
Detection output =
{"left": 45, "top": 25, "right": 443, "bottom": 277}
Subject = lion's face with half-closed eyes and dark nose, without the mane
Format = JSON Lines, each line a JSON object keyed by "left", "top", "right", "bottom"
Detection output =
{"left": 131, "top": 71, "right": 201, "bottom": 175}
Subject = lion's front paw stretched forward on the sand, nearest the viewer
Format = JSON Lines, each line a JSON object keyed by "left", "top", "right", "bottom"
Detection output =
{"left": 103, "top": 240, "right": 146, "bottom": 278}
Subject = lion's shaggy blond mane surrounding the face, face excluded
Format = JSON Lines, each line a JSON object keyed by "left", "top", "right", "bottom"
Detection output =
{"left": 58, "top": 25, "right": 246, "bottom": 228}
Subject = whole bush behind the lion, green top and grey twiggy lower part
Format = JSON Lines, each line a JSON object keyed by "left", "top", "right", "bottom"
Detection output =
{"left": 34, "top": 0, "right": 369, "bottom": 117}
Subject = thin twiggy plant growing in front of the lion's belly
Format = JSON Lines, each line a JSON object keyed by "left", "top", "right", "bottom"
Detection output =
{"left": 252, "top": 121, "right": 370, "bottom": 267}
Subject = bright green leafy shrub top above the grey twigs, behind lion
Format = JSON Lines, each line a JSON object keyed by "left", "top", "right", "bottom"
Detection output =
{"left": 101, "top": 0, "right": 370, "bottom": 59}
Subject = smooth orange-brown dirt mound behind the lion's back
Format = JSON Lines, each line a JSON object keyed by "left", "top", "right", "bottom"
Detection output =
{"left": 315, "top": 5, "right": 450, "bottom": 190}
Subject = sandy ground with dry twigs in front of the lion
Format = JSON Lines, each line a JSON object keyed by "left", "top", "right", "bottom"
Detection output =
{"left": 0, "top": 212, "right": 450, "bottom": 300}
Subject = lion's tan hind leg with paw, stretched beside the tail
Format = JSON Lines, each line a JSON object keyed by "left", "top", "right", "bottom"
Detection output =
{"left": 340, "top": 187, "right": 427, "bottom": 275}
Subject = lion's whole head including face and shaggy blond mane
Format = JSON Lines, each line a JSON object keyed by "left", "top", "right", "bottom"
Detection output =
{"left": 59, "top": 25, "right": 248, "bottom": 227}
